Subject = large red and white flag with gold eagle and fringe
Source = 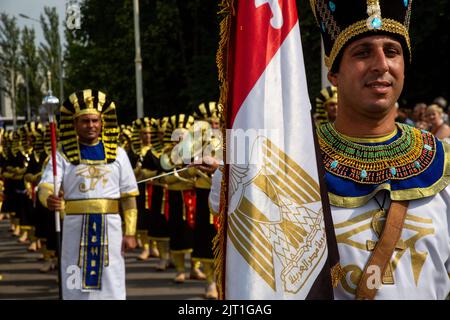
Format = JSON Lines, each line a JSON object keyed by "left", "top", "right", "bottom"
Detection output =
{"left": 215, "top": 0, "right": 340, "bottom": 299}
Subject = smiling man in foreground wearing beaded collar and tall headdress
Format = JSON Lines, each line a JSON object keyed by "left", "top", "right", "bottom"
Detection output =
{"left": 311, "top": 0, "right": 450, "bottom": 299}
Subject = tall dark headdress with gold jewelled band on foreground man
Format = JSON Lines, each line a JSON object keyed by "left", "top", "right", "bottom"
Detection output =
{"left": 310, "top": 0, "right": 412, "bottom": 70}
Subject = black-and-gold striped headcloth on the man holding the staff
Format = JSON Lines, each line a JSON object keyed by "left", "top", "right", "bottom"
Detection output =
{"left": 59, "top": 89, "right": 119, "bottom": 165}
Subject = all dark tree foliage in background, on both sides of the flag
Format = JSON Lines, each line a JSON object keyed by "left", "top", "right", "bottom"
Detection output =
{"left": 61, "top": 0, "right": 450, "bottom": 126}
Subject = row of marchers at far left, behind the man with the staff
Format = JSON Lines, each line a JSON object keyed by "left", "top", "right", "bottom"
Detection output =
{"left": 0, "top": 121, "right": 56, "bottom": 272}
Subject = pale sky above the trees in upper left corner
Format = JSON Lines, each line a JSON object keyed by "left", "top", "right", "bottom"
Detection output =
{"left": 0, "top": 0, "right": 68, "bottom": 45}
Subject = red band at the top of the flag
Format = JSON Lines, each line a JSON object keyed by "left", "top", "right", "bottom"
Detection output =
{"left": 230, "top": 0, "right": 298, "bottom": 124}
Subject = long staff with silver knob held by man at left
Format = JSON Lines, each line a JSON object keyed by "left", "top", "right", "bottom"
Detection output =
{"left": 42, "top": 90, "right": 62, "bottom": 300}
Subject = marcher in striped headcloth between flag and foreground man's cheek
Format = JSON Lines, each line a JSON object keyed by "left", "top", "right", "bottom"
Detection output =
{"left": 314, "top": 86, "right": 338, "bottom": 127}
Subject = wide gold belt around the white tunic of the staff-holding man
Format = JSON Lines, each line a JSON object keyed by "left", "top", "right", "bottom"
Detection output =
{"left": 64, "top": 199, "right": 119, "bottom": 215}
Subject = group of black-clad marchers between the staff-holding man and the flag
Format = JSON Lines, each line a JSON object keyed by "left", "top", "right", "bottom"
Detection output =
{"left": 119, "top": 102, "right": 222, "bottom": 299}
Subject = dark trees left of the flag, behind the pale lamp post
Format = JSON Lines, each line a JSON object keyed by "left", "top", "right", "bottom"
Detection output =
{"left": 65, "top": 0, "right": 218, "bottom": 122}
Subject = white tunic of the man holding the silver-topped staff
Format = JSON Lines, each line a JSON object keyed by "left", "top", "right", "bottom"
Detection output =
{"left": 40, "top": 147, "right": 138, "bottom": 300}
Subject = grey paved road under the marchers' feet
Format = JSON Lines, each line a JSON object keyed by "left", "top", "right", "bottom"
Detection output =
{"left": 0, "top": 220, "right": 206, "bottom": 300}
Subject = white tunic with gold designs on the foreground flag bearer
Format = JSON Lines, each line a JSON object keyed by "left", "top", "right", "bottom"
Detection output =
{"left": 209, "top": 170, "right": 450, "bottom": 300}
